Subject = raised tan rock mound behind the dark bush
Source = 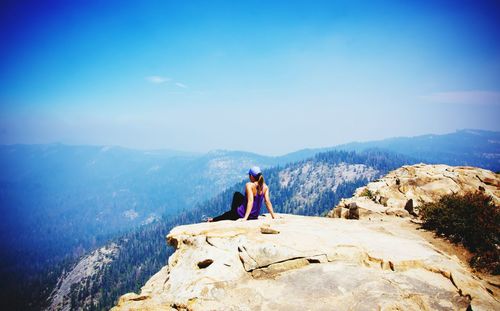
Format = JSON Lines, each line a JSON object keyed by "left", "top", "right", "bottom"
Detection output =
{"left": 328, "top": 164, "right": 500, "bottom": 219}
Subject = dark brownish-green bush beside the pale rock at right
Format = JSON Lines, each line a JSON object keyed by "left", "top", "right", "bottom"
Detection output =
{"left": 420, "top": 192, "right": 500, "bottom": 275}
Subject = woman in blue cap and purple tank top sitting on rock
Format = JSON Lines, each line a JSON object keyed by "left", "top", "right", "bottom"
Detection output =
{"left": 208, "top": 166, "right": 275, "bottom": 222}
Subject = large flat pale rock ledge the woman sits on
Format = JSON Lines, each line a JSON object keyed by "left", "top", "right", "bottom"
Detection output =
{"left": 112, "top": 214, "right": 500, "bottom": 311}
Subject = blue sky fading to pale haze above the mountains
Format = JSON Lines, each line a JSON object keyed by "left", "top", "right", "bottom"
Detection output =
{"left": 0, "top": 0, "right": 500, "bottom": 155}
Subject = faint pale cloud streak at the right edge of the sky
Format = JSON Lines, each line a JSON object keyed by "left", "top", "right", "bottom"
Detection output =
{"left": 422, "top": 91, "right": 500, "bottom": 105}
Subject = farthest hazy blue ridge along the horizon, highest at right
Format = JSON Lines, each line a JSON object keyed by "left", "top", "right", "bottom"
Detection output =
{"left": 0, "top": 129, "right": 500, "bottom": 171}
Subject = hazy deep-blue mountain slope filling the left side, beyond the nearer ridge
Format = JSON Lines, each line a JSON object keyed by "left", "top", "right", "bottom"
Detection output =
{"left": 0, "top": 144, "right": 320, "bottom": 309}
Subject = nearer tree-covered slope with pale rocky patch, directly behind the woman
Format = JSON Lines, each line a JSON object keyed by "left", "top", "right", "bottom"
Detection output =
{"left": 46, "top": 150, "right": 416, "bottom": 310}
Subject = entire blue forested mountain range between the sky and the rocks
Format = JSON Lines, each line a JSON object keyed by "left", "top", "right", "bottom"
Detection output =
{"left": 0, "top": 130, "right": 500, "bottom": 309}
